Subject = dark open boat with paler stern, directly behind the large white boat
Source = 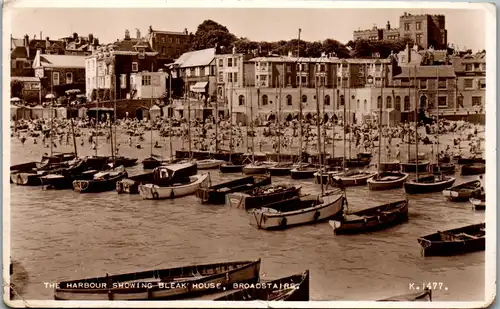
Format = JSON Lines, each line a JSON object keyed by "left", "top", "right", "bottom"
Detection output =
{"left": 226, "top": 185, "right": 301, "bottom": 210}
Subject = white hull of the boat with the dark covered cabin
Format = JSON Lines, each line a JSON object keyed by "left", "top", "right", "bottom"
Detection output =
{"left": 139, "top": 174, "right": 208, "bottom": 200}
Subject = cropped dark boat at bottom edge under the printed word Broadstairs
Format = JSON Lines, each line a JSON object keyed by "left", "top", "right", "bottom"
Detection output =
{"left": 214, "top": 270, "right": 309, "bottom": 301}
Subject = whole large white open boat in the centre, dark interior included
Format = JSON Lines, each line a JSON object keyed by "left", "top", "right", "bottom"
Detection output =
{"left": 248, "top": 190, "right": 344, "bottom": 229}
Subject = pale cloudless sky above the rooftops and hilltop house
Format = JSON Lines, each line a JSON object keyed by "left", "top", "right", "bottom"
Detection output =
{"left": 4, "top": 7, "right": 487, "bottom": 52}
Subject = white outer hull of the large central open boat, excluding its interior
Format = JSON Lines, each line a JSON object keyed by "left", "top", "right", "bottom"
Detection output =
{"left": 249, "top": 191, "right": 344, "bottom": 230}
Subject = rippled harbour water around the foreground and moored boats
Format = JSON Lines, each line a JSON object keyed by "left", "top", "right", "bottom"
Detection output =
{"left": 10, "top": 131, "right": 485, "bottom": 301}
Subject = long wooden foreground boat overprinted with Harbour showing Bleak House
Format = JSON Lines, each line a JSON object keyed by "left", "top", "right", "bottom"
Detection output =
{"left": 54, "top": 259, "right": 260, "bottom": 300}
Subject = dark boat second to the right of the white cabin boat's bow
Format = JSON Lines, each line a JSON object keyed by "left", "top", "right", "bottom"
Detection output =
{"left": 196, "top": 176, "right": 271, "bottom": 204}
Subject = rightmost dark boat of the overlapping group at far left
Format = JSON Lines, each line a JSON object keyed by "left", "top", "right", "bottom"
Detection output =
{"left": 73, "top": 166, "right": 127, "bottom": 193}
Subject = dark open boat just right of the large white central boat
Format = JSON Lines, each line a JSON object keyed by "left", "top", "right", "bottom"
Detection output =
{"left": 329, "top": 200, "right": 408, "bottom": 235}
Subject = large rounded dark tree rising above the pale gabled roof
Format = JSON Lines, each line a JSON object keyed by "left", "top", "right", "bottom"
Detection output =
{"left": 191, "top": 20, "right": 236, "bottom": 50}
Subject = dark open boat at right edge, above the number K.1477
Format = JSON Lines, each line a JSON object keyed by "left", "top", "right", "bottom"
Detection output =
{"left": 418, "top": 223, "right": 486, "bottom": 256}
